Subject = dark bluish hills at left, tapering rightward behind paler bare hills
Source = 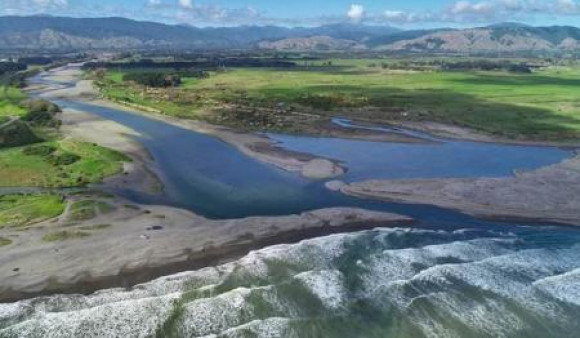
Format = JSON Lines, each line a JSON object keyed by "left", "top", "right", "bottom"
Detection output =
{"left": 0, "top": 16, "right": 398, "bottom": 51}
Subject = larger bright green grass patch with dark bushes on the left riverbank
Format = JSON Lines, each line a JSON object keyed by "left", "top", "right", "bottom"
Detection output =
{"left": 0, "top": 139, "right": 130, "bottom": 187}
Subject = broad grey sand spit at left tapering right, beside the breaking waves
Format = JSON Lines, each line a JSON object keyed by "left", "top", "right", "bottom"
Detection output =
{"left": 0, "top": 195, "right": 412, "bottom": 302}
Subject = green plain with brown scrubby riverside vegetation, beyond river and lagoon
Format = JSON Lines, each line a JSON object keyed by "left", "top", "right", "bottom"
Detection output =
{"left": 93, "top": 58, "right": 580, "bottom": 141}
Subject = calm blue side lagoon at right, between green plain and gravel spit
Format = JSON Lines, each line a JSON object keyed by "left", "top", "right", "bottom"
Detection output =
{"left": 269, "top": 119, "right": 572, "bottom": 182}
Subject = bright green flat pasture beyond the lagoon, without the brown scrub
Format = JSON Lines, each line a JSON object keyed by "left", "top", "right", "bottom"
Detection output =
{"left": 103, "top": 60, "right": 580, "bottom": 140}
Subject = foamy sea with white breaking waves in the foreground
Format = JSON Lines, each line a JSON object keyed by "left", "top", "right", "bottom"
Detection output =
{"left": 0, "top": 227, "right": 580, "bottom": 338}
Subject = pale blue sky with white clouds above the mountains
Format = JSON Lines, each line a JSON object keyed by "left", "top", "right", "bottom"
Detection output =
{"left": 0, "top": 0, "right": 580, "bottom": 29}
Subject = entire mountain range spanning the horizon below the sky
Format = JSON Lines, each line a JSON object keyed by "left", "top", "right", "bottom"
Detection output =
{"left": 0, "top": 16, "right": 580, "bottom": 52}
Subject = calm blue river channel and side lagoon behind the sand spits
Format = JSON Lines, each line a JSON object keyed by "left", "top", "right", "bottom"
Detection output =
{"left": 28, "top": 67, "right": 573, "bottom": 219}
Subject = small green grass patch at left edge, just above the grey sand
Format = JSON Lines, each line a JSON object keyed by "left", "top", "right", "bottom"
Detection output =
{"left": 0, "top": 194, "right": 65, "bottom": 228}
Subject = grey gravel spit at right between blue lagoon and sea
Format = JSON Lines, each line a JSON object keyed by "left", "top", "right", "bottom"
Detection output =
{"left": 338, "top": 156, "right": 580, "bottom": 226}
